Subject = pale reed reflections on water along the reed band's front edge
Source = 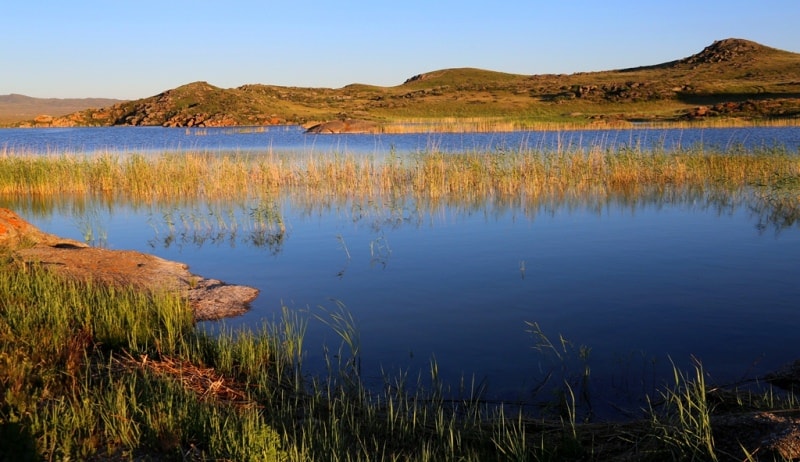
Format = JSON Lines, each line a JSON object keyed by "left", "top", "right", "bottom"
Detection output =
{"left": 37, "top": 188, "right": 788, "bottom": 249}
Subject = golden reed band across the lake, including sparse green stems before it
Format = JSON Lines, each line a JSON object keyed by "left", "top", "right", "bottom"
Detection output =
{"left": 0, "top": 141, "right": 800, "bottom": 238}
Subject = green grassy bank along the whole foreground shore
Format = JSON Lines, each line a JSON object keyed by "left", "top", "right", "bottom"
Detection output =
{"left": 0, "top": 255, "right": 797, "bottom": 461}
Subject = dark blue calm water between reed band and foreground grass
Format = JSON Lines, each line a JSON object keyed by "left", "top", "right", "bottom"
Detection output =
{"left": 3, "top": 188, "right": 800, "bottom": 416}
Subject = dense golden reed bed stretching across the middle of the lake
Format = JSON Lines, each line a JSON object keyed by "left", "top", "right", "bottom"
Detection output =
{"left": 0, "top": 147, "right": 800, "bottom": 206}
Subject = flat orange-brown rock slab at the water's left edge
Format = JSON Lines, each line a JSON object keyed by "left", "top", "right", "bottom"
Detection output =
{"left": 0, "top": 208, "right": 258, "bottom": 321}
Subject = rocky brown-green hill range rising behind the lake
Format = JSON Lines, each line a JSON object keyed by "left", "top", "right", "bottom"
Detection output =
{"left": 7, "top": 39, "right": 800, "bottom": 127}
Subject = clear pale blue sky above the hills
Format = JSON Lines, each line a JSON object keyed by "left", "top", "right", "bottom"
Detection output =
{"left": 0, "top": 0, "right": 800, "bottom": 99}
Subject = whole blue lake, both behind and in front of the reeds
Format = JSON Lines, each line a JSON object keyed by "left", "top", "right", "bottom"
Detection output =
{"left": 0, "top": 127, "right": 800, "bottom": 412}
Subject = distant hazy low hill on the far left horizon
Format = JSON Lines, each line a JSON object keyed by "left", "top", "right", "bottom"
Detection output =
{"left": 0, "top": 94, "right": 122, "bottom": 124}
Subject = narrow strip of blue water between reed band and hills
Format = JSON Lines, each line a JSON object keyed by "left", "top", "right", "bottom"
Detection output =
{"left": 0, "top": 126, "right": 800, "bottom": 155}
